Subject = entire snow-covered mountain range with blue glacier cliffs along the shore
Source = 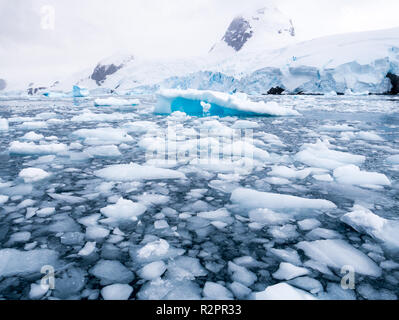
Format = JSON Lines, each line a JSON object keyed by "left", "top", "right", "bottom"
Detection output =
{"left": 16, "top": 6, "right": 399, "bottom": 94}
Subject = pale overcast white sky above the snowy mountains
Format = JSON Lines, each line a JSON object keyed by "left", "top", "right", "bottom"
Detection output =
{"left": 0, "top": 0, "right": 399, "bottom": 84}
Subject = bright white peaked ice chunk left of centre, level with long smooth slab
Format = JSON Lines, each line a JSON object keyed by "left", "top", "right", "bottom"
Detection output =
{"left": 100, "top": 198, "right": 147, "bottom": 221}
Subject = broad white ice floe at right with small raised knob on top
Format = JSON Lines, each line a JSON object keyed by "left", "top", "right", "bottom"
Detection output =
{"left": 295, "top": 140, "right": 366, "bottom": 169}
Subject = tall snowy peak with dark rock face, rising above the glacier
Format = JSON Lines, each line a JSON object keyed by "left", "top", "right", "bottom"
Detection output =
{"left": 210, "top": 5, "right": 295, "bottom": 56}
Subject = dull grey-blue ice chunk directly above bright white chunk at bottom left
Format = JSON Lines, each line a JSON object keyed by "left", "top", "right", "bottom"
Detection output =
{"left": 90, "top": 260, "right": 134, "bottom": 285}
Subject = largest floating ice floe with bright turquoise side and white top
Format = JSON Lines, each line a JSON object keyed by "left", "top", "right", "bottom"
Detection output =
{"left": 155, "top": 89, "right": 299, "bottom": 116}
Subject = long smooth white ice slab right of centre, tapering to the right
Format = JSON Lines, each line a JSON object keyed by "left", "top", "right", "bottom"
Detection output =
{"left": 231, "top": 188, "right": 336, "bottom": 210}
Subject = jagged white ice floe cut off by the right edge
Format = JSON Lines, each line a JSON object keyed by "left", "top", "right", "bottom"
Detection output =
{"left": 341, "top": 205, "right": 399, "bottom": 250}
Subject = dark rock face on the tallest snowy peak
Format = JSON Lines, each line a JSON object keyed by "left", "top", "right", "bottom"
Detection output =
{"left": 223, "top": 17, "right": 253, "bottom": 51}
